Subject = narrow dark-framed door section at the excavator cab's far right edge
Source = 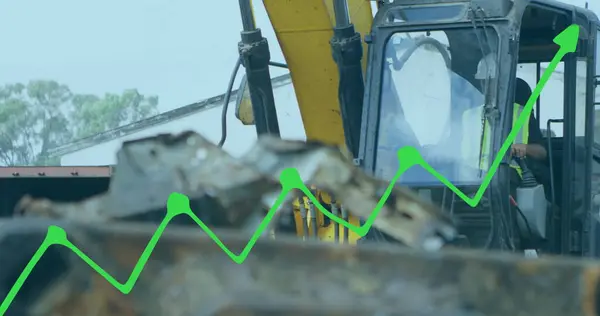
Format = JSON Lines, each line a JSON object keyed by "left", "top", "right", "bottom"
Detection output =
{"left": 560, "top": 22, "right": 600, "bottom": 256}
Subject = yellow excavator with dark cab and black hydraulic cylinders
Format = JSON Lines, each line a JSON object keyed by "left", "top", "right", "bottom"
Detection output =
{"left": 231, "top": 0, "right": 600, "bottom": 256}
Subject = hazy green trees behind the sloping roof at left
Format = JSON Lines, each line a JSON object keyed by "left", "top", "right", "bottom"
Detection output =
{"left": 0, "top": 80, "right": 158, "bottom": 166}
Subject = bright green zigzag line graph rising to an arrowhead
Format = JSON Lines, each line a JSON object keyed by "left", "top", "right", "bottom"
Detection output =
{"left": 0, "top": 25, "right": 579, "bottom": 316}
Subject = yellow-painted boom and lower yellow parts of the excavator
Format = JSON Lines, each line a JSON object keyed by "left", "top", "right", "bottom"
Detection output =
{"left": 263, "top": 0, "right": 373, "bottom": 244}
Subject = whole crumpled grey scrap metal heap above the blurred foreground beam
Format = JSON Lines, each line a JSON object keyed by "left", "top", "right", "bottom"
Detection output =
{"left": 18, "top": 132, "right": 455, "bottom": 248}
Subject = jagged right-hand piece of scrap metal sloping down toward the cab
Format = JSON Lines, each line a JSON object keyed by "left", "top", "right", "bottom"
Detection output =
{"left": 243, "top": 136, "right": 455, "bottom": 248}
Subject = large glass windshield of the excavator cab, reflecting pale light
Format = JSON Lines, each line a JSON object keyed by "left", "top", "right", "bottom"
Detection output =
{"left": 376, "top": 28, "right": 498, "bottom": 186}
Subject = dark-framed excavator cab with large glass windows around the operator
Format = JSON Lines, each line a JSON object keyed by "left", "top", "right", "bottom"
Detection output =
{"left": 358, "top": 0, "right": 600, "bottom": 256}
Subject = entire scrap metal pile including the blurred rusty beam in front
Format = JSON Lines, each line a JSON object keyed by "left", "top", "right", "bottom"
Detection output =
{"left": 0, "top": 133, "right": 600, "bottom": 316}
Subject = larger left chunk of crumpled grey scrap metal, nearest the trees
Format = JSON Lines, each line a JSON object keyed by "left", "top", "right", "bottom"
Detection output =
{"left": 17, "top": 133, "right": 280, "bottom": 231}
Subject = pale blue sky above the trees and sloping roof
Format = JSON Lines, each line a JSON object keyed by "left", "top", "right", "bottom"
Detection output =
{"left": 0, "top": 0, "right": 600, "bottom": 111}
